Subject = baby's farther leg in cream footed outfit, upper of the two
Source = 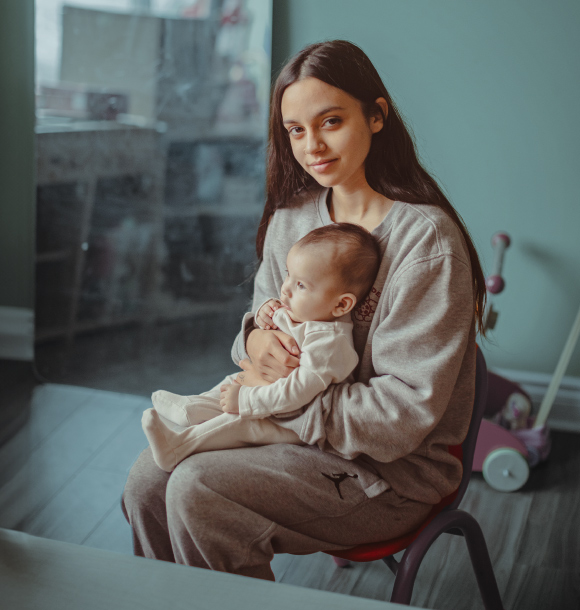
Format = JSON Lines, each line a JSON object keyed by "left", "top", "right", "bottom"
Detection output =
{"left": 151, "top": 373, "right": 237, "bottom": 427}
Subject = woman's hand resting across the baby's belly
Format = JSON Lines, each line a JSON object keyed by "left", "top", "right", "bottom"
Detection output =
{"left": 246, "top": 328, "right": 300, "bottom": 383}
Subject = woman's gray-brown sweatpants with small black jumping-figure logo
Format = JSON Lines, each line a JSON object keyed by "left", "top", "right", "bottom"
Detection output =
{"left": 122, "top": 444, "right": 431, "bottom": 580}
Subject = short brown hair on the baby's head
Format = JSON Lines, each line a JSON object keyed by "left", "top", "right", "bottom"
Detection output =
{"left": 296, "top": 222, "right": 382, "bottom": 304}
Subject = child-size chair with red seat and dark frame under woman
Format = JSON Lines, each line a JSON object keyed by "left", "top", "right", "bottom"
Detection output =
{"left": 328, "top": 348, "right": 503, "bottom": 610}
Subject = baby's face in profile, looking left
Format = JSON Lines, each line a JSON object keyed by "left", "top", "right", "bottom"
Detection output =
{"left": 280, "top": 246, "right": 351, "bottom": 322}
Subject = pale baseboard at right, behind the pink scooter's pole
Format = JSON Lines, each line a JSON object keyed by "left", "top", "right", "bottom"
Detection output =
{"left": 490, "top": 368, "right": 580, "bottom": 432}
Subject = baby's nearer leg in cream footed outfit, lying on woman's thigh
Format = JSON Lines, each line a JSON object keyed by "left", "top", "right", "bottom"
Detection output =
{"left": 142, "top": 409, "right": 304, "bottom": 472}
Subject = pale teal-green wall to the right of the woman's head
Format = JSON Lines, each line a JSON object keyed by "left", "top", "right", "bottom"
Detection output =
{"left": 273, "top": 0, "right": 580, "bottom": 376}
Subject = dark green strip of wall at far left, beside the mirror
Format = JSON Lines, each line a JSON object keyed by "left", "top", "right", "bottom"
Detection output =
{"left": 0, "top": 0, "right": 35, "bottom": 309}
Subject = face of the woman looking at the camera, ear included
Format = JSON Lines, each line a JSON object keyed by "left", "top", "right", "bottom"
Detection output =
{"left": 281, "top": 77, "right": 383, "bottom": 191}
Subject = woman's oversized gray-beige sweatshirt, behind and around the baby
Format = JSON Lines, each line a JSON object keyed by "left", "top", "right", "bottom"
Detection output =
{"left": 232, "top": 189, "right": 475, "bottom": 504}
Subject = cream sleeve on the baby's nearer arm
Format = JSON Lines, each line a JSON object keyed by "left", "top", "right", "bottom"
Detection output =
{"left": 239, "top": 329, "right": 358, "bottom": 419}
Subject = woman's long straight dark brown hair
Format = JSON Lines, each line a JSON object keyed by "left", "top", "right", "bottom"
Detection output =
{"left": 256, "top": 40, "right": 486, "bottom": 335}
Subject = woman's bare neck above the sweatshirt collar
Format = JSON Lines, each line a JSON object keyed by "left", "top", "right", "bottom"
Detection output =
{"left": 328, "top": 184, "right": 394, "bottom": 231}
